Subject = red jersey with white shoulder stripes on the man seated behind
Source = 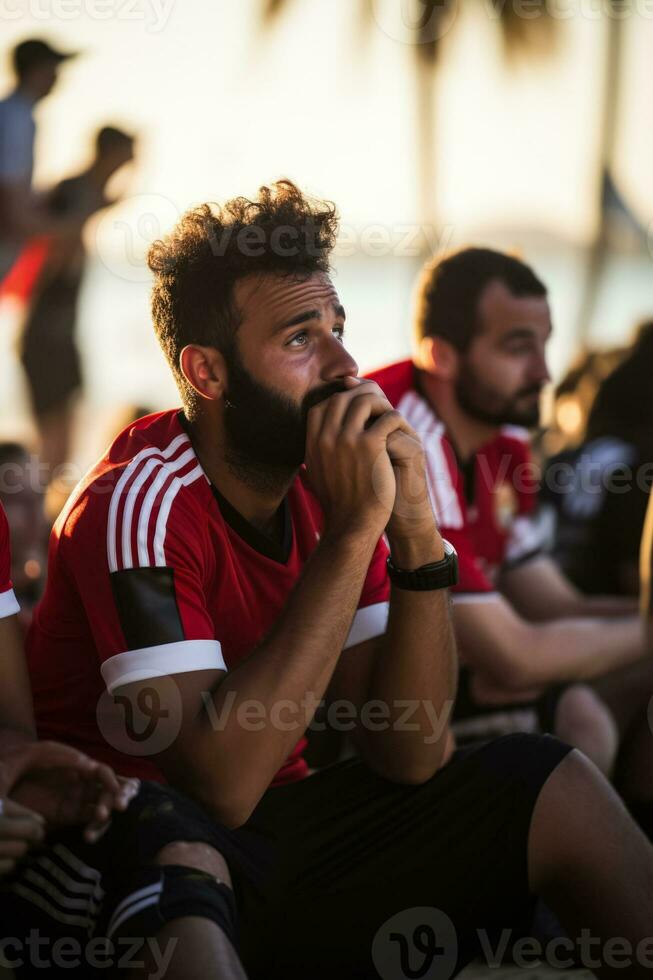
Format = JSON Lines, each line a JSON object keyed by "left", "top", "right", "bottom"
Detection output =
{"left": 368, "top": 361, "right": 543, "bottom": 601}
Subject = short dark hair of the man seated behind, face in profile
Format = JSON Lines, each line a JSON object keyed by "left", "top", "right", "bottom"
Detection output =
{"left": 415, "top": 248, "right": 547, "bottom": 351}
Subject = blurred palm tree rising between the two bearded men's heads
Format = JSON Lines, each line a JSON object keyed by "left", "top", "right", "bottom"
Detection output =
{"left": 261, "top": 0, "right": 556, "bottom": 228}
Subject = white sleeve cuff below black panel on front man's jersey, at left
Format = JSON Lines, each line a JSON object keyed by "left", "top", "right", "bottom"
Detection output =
{"left": 101, "top": 640, "right": 227, "bottom": 694}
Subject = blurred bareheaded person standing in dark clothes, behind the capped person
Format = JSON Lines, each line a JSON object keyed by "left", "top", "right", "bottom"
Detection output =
{"left": 20, "top": 126, "right": 134, "bottom": 489}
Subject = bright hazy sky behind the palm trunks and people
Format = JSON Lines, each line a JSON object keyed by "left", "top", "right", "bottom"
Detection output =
{"left": 0, "top": 0, "right": 653, "bottom": 452}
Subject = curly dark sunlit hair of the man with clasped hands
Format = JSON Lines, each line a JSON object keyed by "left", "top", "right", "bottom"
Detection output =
{"left": 148, "top": 180, "right": 338, "bottom": 419}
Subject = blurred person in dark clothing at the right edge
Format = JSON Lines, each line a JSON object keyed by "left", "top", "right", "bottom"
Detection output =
{"left": 542, "top": 322, "right": 653, "bottom": 602}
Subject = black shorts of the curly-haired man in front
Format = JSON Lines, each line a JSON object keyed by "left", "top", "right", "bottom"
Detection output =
{"left": 3, "top": 735, "right": 570, "bottom": 980}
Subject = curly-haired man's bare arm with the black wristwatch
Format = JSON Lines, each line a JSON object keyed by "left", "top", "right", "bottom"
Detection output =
{"left": 330, "top": 433, "right": 458, "bottom": 783}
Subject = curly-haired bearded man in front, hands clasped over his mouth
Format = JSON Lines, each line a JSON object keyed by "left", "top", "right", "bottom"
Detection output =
{"left": 21, "top": 193, "right": 653, "bottom": 980}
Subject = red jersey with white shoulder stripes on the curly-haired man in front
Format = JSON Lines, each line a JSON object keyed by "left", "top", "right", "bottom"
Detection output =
{"left": 27, "top": 411, "right": 389, "bottom": 784}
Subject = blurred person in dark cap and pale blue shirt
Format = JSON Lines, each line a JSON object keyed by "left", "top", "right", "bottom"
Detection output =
{"left": 0, "top": 38, "right": 85, "bottom": 289}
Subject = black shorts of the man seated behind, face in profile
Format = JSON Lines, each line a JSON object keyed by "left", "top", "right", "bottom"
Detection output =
{"left": 452, "top": 667, "right": 566, "bottom": 745}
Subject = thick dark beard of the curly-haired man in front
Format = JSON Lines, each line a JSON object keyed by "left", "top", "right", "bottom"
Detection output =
{"left": 224, "top": 347, "right": 344, "bottom": 489}
